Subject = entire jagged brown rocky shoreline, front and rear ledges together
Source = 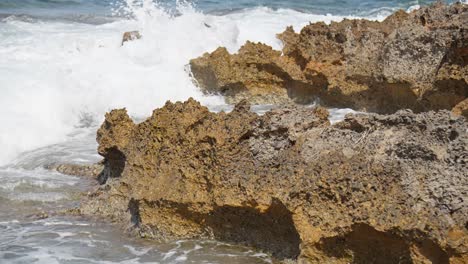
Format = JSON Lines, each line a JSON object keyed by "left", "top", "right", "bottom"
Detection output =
{"left": 51, "top": 4, "right": 468, "bottom": 263}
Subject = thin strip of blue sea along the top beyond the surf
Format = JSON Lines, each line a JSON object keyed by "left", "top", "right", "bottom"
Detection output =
{"left": 0, "top": 0, "right": 460, "bottom": 16}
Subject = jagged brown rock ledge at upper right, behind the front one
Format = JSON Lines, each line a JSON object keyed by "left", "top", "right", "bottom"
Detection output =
{"left": 190, "top": 3, "right": 468, "bottom": 117}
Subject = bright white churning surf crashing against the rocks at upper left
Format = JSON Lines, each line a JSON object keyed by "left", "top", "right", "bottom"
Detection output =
{"left": 0, "top": 0, "right": 370, "bottom": 165}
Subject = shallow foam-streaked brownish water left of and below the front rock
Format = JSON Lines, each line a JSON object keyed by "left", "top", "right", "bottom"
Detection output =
{"left": 0, "top": 117, "right": 278, "bottom": 264}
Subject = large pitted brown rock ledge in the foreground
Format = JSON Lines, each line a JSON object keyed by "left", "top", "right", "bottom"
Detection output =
{"left": 80, "top": 99, "right": 468, "bottom": 263}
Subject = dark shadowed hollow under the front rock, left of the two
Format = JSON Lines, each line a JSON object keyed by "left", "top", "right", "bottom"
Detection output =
{"left": 137, "top": 200, "right": 301, "bottom": 260}
